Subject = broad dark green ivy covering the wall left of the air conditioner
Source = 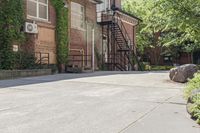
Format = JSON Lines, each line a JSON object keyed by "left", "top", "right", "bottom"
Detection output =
{"left": 0, "top": 0, "right": 25, "bottom": 69}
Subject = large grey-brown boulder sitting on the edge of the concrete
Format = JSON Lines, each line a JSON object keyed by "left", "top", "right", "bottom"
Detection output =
{"left": 169, "top": 64, "right": 198, "bottom": 83}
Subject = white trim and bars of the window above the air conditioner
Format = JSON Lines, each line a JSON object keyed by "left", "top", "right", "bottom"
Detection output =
{"left": 27, "top": 0, "right": 49, "bottom": 21}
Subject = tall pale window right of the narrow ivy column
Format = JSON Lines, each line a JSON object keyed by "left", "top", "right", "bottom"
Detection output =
{"left": 71, "top": 2, "right": 85, "bottom": 29}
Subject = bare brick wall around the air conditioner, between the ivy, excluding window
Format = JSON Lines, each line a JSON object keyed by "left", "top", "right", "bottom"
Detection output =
{"left": 23, "top": 1, "right": 57, "bottom": 64}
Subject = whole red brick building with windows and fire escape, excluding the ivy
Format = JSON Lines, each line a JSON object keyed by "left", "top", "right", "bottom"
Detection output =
{"left": 25, "top": 0, "right": 139, "bottom": 70}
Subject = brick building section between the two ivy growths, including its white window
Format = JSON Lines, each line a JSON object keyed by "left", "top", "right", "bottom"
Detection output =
{"left": 24, "top": 0, "right": 56, "bottom": 64}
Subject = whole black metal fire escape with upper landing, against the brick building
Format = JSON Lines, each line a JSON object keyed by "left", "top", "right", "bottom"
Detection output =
{"left": 97, "top": 10, "right": 137, "bottom": 71}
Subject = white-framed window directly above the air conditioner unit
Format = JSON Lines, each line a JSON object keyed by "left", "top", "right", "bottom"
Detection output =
{"left": 27, "top": 0, "right": 48, "bottom": 20}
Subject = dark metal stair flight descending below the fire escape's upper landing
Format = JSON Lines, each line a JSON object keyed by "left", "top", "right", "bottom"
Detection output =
{"left": 107, "top": 13, "right": 134, "bottom": 71}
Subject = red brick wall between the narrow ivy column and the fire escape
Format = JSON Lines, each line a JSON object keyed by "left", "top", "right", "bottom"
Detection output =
{"left": 69, "top": 0, "right": 101, "bottom": 67}
